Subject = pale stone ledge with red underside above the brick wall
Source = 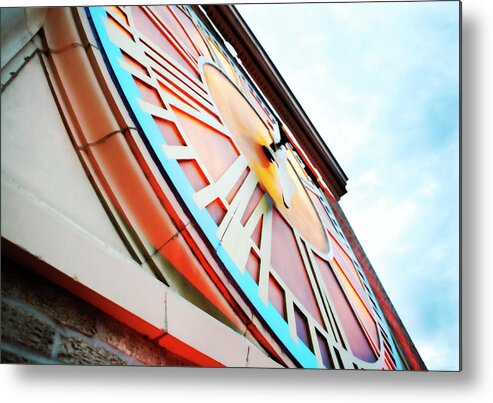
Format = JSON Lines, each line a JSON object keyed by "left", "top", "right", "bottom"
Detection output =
{"left": 1, "top": 175, "right": 280, "bottom": 368}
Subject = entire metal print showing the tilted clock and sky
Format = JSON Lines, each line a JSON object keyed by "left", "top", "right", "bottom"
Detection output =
{"left": 2, "top": 2, "right": 460, "bottom": 370}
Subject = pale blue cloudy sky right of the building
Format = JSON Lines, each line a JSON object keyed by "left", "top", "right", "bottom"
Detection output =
{"left": 237, "top": 1, "right": 459, "bottom": 370}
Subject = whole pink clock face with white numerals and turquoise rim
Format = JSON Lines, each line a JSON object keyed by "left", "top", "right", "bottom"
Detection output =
{"left": 88, "top": 6, "right": 400, "bottom": 369}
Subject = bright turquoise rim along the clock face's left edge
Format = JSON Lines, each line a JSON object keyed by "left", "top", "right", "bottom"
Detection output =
{"left": 86, "top": 7, "right": 318, "bottom": 368}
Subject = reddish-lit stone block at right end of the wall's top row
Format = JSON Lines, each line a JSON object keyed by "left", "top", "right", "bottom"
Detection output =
{"left": 98, "top": 316, "right": 194, "bottom": 367}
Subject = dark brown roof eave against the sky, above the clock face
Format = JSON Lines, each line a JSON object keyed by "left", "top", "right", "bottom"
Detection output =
{"left": 192, "top": 5, "right": 348, "bottom": 200}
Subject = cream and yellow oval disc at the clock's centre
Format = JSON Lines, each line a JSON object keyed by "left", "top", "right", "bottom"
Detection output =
{"left": 203, "top": 63, "right": 329, "bottom": 253}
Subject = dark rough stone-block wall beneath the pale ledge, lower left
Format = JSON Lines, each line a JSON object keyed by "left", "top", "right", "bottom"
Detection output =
{"left": 0, "top": 257, "right": 193, "bottom": 366}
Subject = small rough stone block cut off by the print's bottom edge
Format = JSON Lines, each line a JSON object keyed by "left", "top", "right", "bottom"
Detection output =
{"left": 57, "top": 336, "right": 127, "bottom": 365}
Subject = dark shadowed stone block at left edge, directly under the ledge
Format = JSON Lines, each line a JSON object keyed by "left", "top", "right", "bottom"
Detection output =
{"left": 2, "top": 260, "right": 97, "bottom": 336}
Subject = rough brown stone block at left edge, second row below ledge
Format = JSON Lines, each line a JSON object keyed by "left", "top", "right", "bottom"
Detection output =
{"left": 1, "top": 301, "right": 55, "bottom": 357}
